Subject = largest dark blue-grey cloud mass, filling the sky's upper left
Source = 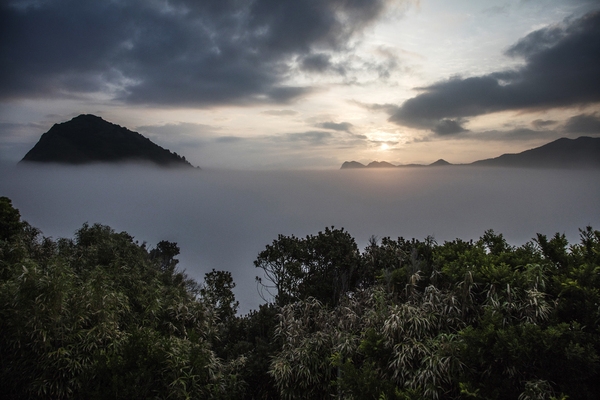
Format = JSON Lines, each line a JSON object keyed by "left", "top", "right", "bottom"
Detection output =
{"left": 0, "top": 0, "right": 396, "bottom": 105}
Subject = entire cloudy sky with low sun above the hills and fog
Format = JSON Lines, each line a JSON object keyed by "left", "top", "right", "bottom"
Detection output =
{"left": 0, "top": 0, "right": 600, "bottom": 170}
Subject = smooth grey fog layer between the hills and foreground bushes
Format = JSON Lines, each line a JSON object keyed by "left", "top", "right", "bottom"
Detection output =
{"left": 0, "top": 165, "right": 600, "bottom": 313}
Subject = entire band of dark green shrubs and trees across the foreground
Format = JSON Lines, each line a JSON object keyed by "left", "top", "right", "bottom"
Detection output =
{"left": 0, "top": 197, "right": 600, "bottom": 400}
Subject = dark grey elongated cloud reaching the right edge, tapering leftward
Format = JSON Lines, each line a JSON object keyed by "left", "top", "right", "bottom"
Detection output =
{"left": 388, "top": 11, "right": 600, "bottom": 134}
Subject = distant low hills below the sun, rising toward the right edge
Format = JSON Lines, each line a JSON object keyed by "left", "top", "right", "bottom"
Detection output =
{"left": 341, "top": 136, "right": 600, "bottom": 169}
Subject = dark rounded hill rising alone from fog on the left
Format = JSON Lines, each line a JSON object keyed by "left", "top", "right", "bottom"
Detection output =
{"left": 20, "top": 114, "right": 193, "bottom": 168}
